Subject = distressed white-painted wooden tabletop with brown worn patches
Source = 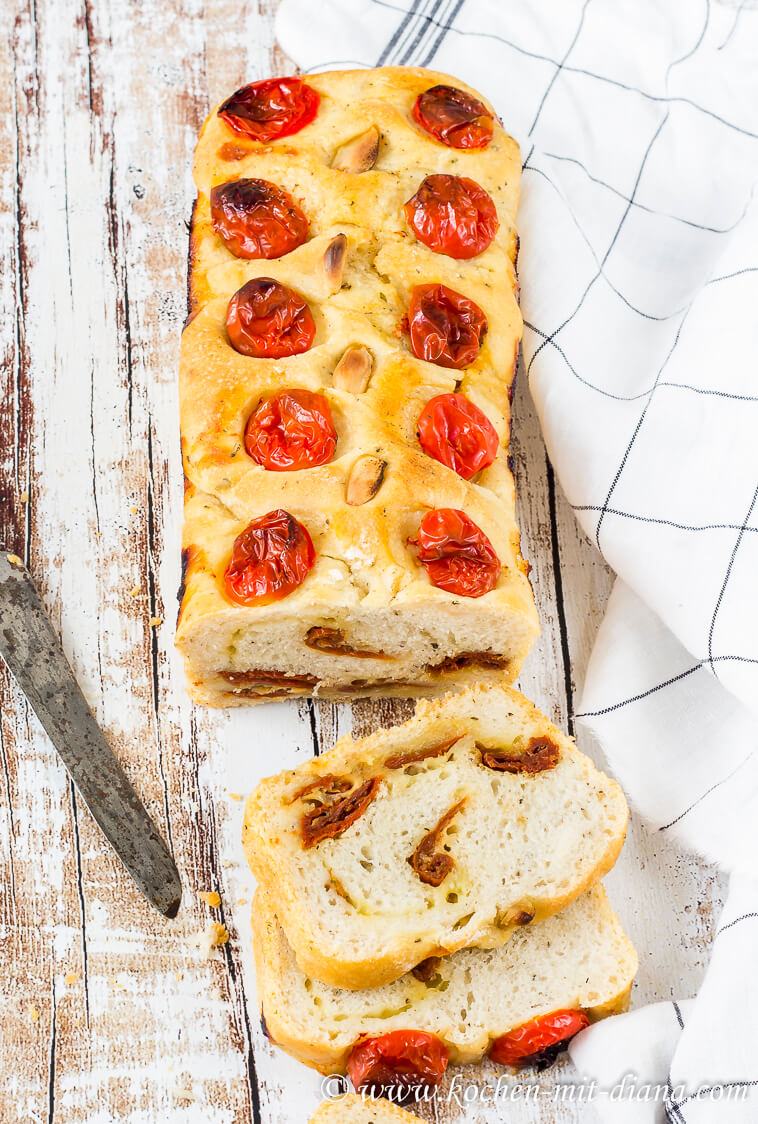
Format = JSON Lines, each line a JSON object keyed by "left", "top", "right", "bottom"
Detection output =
{"left": 0, "top": 0, "right": 723, "bottom": 1124}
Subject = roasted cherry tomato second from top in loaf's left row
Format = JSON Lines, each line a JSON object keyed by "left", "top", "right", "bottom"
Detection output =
{"left": 210, "top": 180, "right": 308, "bottom": 257}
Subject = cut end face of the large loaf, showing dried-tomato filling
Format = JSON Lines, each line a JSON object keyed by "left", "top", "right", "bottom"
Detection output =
{"left": 175, "top": 609, "right": 533, "bottom": 706}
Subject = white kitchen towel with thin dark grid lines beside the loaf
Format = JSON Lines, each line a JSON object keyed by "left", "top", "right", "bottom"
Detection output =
{"left": 277, "top": 0, "right": 758, "bottom": 1124}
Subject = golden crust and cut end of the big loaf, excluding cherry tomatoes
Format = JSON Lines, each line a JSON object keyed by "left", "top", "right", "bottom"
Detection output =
{"left": 177, "top": 67, "right": 539, "bottom": 706}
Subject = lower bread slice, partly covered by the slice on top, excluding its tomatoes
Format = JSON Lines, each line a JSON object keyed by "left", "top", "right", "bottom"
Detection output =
{"left": 253, "top": 886, "right": 638, "bottom": 1073}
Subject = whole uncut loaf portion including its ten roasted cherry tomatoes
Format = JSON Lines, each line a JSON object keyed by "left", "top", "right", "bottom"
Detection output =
{"left": 177, "top": 67, "right": 539, "bottom": 706}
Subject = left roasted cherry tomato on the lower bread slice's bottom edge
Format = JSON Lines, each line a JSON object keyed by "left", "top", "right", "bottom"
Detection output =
{"left": 348, "top": 1031, "right": 450, "bottom": 1100}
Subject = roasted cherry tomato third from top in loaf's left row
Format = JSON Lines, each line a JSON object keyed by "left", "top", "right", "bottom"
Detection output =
{"left": 226, "top": 278, "right": 316, "bottom": 359}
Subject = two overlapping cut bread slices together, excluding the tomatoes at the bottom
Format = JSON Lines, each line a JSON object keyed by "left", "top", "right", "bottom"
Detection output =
{"left": 243, "top": 685, "right": 637, "bottom": 1092}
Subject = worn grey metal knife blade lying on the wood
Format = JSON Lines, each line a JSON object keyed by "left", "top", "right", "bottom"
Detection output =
{"left": 0, "top": 550, "right": 181, "bottom": 917}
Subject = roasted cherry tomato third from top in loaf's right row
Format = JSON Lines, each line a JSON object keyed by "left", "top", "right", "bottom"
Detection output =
{"left": 408, "top": 284, "right": 487, "bottom": 370}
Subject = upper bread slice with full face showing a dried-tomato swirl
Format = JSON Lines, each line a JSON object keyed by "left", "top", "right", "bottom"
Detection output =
{"left": 243, "top": 686, "right": 629, "bottom": 989}
